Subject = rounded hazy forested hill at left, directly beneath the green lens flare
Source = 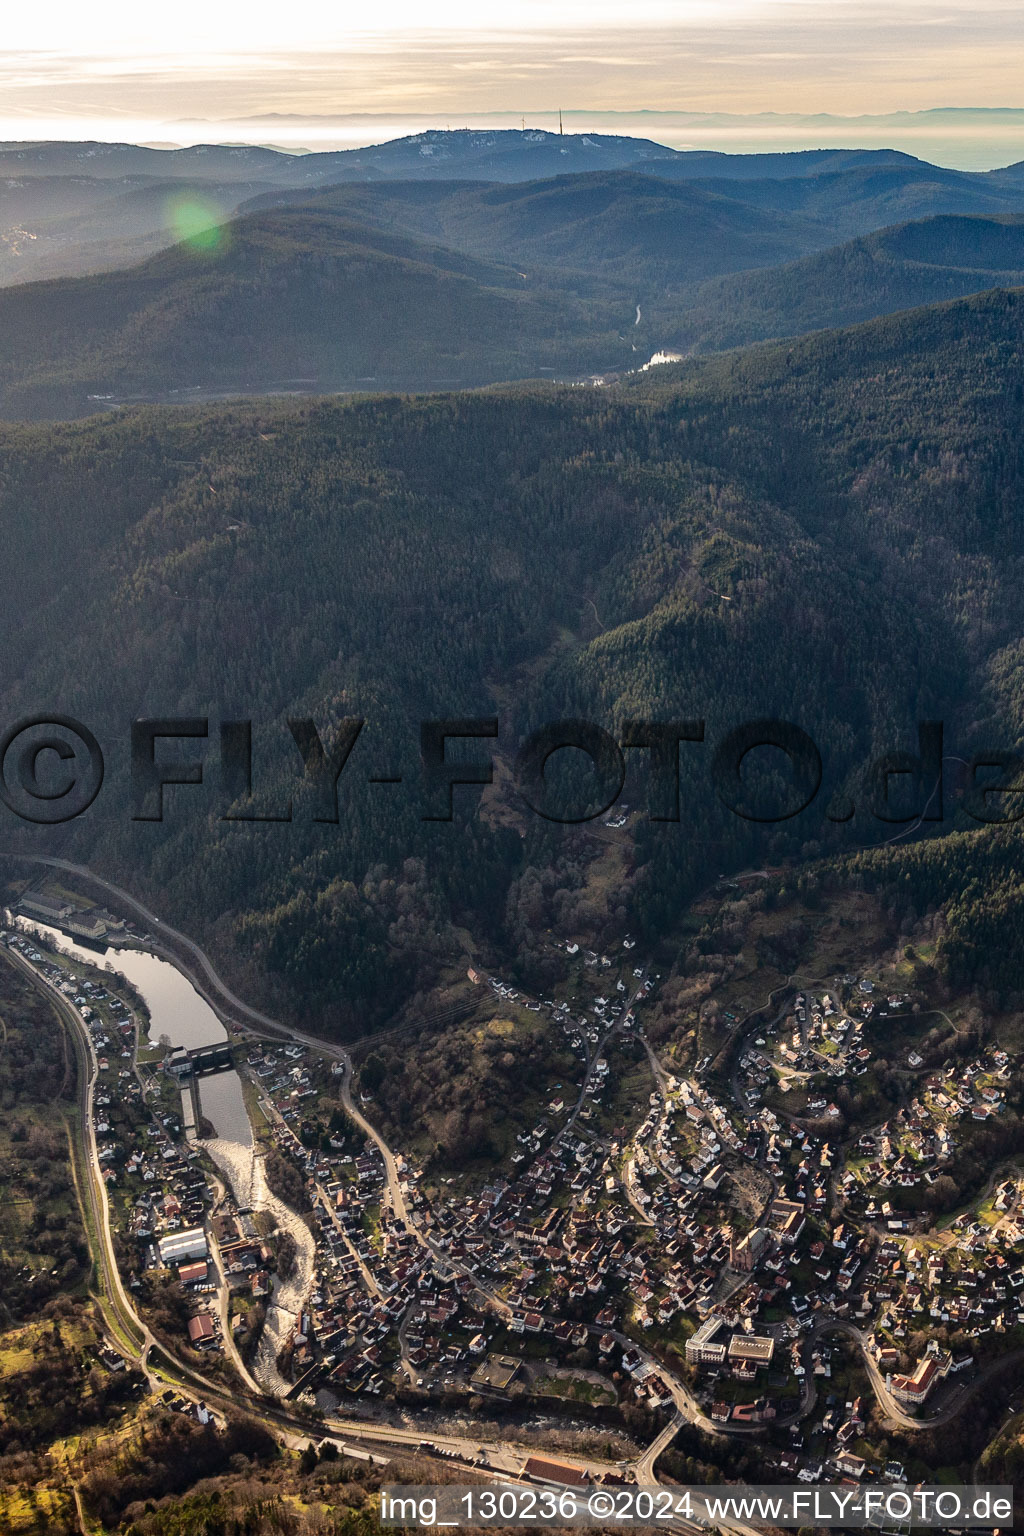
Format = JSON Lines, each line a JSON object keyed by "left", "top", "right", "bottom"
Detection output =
{"left": 0, "top": 210, "right": 634, "bottom": 418}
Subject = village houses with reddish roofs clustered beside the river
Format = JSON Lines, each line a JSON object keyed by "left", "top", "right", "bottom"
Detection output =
{"left": 3, "top": 909, "right": 1024, "bottom": 1481}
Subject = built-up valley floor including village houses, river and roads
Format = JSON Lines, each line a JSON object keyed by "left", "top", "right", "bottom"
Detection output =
{"left": 5, "top": 876, "right": 1024, "bottom": 1529}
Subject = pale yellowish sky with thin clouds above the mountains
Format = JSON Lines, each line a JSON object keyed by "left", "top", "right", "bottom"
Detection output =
{"left": 0, "top": 0, "right": 1024, "bottom": 162}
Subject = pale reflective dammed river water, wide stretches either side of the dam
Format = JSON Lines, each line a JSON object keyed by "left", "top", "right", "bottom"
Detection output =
{"left": 18, "top": 915, "right": 252, "bottom": 1147}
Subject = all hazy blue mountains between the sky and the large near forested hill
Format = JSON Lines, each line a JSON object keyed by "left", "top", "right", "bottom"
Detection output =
{"left": 0, "top": 131, "right": 1024, "bottom": 405}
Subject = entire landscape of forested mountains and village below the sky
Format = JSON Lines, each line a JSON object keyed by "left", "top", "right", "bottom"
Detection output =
{"left": 0, "top": 118, "right": 1024, "bottom": 1536}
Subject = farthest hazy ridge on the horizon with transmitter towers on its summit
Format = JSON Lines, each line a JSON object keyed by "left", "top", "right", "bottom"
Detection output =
{"left": 0, "top": 129, "right": 1024, "bottom": 296}
